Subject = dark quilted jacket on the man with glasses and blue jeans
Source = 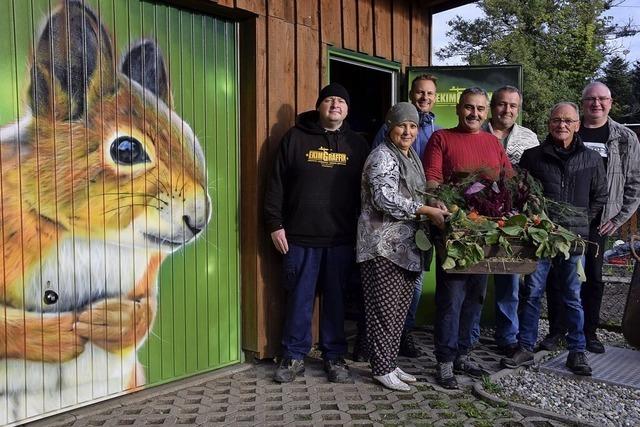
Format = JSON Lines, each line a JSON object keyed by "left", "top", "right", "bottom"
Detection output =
{"left": 520, "top": 134, "right": 607, "bottom": 238}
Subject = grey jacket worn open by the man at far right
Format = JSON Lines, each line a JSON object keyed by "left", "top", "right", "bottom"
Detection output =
{"left": 601, "top": 118, "right": 640, "bottom": 227}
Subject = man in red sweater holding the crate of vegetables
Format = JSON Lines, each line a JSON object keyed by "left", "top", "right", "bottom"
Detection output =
{"left": 422, "top": 87, "right": 512, "bottom": 389}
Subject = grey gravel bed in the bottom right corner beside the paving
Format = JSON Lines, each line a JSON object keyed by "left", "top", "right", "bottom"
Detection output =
{"left": 496, "top": 369, "right": 640, "bottom": 426}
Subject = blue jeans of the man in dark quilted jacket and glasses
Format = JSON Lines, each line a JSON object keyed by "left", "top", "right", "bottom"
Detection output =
{"left": 519, "top": 255, "right": 585, "bottom": 352}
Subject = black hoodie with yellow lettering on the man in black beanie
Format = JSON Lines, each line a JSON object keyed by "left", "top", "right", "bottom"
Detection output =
{"left": 265, "top": 111, "right": 369, "bottom": 247}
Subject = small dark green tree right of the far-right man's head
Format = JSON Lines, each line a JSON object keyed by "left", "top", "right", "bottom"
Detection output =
{"left": 602, "top": 55, "right": 637, "bottom": 123}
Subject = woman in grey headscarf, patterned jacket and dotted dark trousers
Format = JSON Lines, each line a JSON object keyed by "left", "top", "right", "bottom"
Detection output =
{"left": 357, "top": 102, "right": 448, "bottom": 391}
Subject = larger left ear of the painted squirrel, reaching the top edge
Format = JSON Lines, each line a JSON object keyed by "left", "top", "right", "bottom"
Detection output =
{"left": 29, "top": 0, "right": 116, "bottom": 120}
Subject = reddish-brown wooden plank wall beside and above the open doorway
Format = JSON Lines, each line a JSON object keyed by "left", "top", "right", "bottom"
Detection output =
{"left": 200, "top": 0, "right": 442, "bottom": 358}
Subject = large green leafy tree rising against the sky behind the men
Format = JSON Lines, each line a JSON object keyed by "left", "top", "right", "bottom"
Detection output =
{"left": 436, "top": 0, "right": 630, "bottom": 137}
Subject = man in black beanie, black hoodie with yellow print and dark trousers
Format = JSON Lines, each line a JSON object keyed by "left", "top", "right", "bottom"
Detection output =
{"left": 265, "top": 83, "right": 368, "bottom": 383}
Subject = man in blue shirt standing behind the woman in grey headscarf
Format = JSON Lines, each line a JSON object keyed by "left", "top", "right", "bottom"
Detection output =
{"left": 371, "top": 74, "right": 439, "bottom": 357}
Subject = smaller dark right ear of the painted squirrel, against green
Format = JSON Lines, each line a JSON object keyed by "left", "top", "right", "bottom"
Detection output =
{"left": 120, "top": 39, "right": 171, "bottom": 105}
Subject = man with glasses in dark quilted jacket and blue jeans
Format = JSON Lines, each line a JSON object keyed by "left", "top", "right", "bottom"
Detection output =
{"left": 501, "top": 102, "right": 607, "bottom": 375}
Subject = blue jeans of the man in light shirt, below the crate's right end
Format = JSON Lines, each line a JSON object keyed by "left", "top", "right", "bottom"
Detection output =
{"left": 493, "top": 274, "right": 520, "bottom": 347}
